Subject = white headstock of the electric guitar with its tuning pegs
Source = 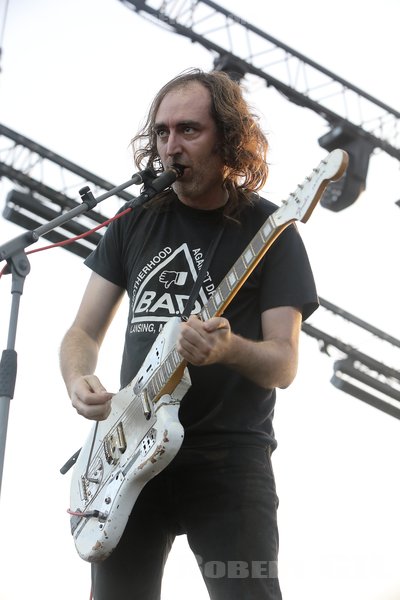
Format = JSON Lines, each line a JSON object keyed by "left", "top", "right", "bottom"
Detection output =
{"left": 274, "top": 148, "right": 349, "bottom": 223}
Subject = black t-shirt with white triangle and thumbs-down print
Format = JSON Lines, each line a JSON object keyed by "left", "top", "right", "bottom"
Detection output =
{"left": 86, "top": 193, "right": 318, "bottom": 445}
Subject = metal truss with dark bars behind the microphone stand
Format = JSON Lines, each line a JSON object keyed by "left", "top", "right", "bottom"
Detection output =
{"left": 0, "top": 124, "right": 134, "bottom": 258}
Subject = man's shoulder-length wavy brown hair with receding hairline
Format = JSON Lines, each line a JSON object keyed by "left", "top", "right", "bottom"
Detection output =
{"left": 131, "top": 69, "right": 268, "bottom": 214}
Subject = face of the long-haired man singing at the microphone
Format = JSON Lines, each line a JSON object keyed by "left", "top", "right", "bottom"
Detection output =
{"left": 154, "top": 82, "right": 227, "bottom": 209}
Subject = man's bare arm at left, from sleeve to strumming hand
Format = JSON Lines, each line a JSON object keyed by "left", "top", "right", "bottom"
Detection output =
{"left": 60, "top": 273, "right": 123, "bottom": 420}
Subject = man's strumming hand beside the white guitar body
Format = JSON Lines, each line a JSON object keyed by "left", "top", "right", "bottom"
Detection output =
{"left": 70, "top": 375, "right": 114, "bottom": 421}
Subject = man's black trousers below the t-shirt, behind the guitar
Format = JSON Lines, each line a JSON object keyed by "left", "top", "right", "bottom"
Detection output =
{"left": 92, "top": 446, "right": 281, "bottom": 600}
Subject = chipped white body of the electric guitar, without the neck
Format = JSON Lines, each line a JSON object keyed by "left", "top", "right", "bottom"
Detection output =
{"left": 70, "top": 318, "right": 190, "bottom": 562}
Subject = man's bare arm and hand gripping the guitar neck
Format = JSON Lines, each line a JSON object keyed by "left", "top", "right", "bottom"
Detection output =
{"left": 177, "top": 306, "right": 301, "bottom": 389}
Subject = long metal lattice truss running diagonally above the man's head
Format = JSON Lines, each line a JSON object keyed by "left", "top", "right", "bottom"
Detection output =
{"left": 120, "top": 0, "right": 400, "bottom": 160}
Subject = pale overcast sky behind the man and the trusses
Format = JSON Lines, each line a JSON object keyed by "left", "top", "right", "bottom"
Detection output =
{"left": 0, "top": 0, "right": 400, "bottom": 600}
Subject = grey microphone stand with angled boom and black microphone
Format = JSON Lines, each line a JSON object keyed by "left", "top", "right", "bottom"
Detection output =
{"left": 0, "top": 165, "right": 183, "bottom": 500}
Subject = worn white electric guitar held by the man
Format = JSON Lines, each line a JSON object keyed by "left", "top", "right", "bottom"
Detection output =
{"left": 69, "top": 150, "right": 348, "bottom": 562}
